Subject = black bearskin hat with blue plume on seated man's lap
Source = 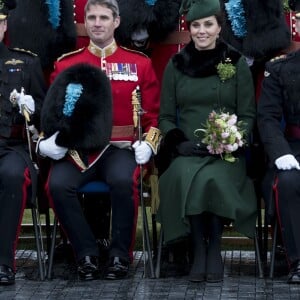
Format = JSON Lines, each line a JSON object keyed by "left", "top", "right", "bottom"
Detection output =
{"left": 41, "top": 64, "right": 112, "bottom": 151}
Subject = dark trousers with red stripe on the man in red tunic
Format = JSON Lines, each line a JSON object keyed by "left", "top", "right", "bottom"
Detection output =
{"left": 47, "top": 146, "right": 138, "bottom": 261}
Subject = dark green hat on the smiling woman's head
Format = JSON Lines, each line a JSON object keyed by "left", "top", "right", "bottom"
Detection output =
{"left": 179, "top": 0, "right": 221, "bottom": 22}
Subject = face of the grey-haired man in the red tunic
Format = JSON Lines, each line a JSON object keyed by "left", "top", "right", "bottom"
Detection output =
{"left": 84, "top": 5, "right": 120, "bottom": 48}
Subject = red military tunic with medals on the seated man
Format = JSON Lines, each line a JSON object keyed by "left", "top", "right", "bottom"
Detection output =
{"left": 50, "top": 42, "right": 159, "bottom": 164}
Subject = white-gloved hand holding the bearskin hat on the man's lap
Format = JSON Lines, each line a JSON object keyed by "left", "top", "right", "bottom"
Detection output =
{"left": 38, "top": 131, "right": 68, "bottom": 160}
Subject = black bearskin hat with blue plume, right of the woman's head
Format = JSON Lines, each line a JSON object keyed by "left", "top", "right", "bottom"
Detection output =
{"left": 221, "top": 0, "right": 291, "bottom": 59}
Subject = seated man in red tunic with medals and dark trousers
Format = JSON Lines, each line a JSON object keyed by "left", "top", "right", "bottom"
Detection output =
{"left": 38, "top": 0, "right": 160, "bottom": 280}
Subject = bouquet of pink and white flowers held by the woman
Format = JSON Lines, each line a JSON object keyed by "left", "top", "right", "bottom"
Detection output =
{"left": 194, "top": 111, "right": 245, "bottom": 162}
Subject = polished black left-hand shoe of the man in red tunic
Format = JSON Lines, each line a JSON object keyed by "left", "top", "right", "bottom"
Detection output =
{"left": 78, "top": 256, "right": 100, "bottom": 280}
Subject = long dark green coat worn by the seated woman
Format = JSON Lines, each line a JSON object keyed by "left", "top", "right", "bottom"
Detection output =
{"left": 158, "top": 47, "right": 257, "bottom": 242}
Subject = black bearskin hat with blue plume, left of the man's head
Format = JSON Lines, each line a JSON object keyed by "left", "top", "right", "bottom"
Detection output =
{"left": 8, "top": 0, "right": 77, "bottom": 70}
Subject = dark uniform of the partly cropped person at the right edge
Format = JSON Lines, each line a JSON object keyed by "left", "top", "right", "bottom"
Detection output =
{"left": 258, "top": 51, "right": 300, "bottom": 278}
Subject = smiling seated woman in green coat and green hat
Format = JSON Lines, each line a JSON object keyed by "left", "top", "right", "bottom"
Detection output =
{"left": 158, "top": 0, "right": 257, "bottom": 282}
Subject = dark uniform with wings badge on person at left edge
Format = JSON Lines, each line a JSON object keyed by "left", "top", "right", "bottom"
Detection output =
{"left": 0, "top": 42, "right": 45, "bottom": 284}
